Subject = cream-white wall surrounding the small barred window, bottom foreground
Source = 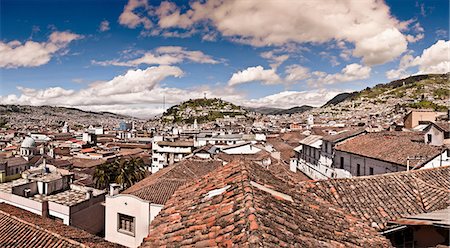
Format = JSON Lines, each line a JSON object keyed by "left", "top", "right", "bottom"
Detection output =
{"left": 105, "top": 194, "right": 153, "bottom": 247}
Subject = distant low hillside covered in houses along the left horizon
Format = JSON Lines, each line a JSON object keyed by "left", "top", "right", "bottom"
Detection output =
{"left": 0, "top": 105, "right": 133, "bottom": 127}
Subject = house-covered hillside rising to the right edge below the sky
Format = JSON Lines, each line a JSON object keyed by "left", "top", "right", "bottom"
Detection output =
{"left": 305, "top": 74, "right": 450, "bottom": 124}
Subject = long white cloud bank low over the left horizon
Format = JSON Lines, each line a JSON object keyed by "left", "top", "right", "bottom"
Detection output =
{"left": 0, "top": 66, "right": 183, "bottom": 106}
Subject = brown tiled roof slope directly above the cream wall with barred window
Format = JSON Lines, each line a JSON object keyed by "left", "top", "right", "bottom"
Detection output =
{"left": 122, "top": 159, "right": 222, "bottom": 205}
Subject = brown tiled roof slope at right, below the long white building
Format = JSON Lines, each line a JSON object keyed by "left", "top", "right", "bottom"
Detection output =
{"left": 299, "top": 166, "right": 450, "bottom": 230}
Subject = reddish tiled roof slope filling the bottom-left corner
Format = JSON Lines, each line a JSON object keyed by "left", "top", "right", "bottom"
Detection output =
{"left": 0, "top": 203, "right": 122, "bottom": 248}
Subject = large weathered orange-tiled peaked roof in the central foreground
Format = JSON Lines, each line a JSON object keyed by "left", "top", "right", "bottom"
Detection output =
{"left": 142, "top": 161, "right": 390, "bottom": 247}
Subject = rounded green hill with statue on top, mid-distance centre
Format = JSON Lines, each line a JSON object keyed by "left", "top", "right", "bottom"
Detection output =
{"left": 162, "top": 98, "right": 247, "bottom": 124}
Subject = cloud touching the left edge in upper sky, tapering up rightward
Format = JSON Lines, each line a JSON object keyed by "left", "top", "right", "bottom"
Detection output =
{"left": 0, "top": 31, "right": 83, "bottom": 68}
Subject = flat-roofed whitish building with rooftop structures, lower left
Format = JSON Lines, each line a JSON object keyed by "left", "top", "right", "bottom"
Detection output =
{"left": 0, "top": 162, "right": 105, "bottom": 234}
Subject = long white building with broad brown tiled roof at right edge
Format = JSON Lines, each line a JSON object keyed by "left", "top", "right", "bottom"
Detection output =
{"left": 333, "top": 132, "right": 450, "bottom": 176}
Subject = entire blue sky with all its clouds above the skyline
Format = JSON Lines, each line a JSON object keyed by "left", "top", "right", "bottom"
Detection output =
{"left": 0, "top": 0, "right": 450, "bottom": 117}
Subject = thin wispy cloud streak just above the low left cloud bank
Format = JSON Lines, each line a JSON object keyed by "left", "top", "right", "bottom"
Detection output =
{"left": 92, "top": 46, "right": 219, "bottom": 66}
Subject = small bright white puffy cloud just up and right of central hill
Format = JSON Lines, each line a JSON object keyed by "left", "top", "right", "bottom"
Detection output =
{"left": 228, "top": 65, "right": 281, "bottom": 86}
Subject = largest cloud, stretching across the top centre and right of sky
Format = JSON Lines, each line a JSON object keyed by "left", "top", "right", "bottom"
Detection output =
{"left": 125, "top": 0, "right": 420, "bottom": 65}
